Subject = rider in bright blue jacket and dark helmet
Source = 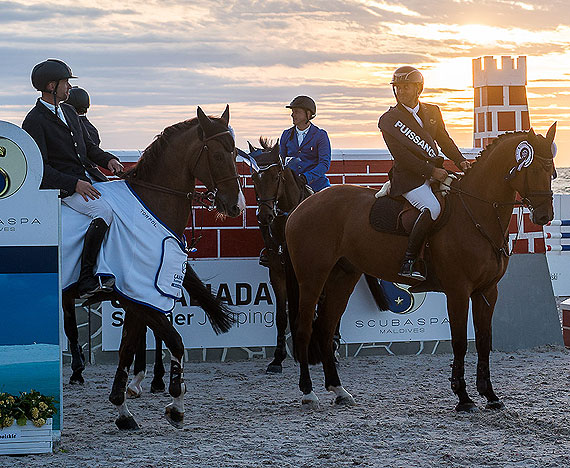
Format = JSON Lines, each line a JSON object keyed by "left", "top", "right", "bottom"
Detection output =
{"left": 279, "top": 96, "right": 331, "bottom": 192}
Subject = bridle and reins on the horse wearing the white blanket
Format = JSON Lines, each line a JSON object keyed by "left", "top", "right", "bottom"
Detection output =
{"left": 127, "top": 130, "right": 238, "bottom": 211}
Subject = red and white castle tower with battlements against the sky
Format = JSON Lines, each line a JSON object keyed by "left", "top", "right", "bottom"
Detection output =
{"left": 473, "top": 56, "right": 530, "bottom": 148}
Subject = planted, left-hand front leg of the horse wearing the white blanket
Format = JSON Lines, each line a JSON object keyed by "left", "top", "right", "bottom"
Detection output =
{"left": 109, "top": 309, "right": 146, "bottom": 430}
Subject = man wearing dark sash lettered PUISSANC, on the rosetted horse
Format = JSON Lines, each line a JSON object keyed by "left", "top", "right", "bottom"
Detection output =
{"left": 378, "top": 65, "right": 471, "bottom": 281}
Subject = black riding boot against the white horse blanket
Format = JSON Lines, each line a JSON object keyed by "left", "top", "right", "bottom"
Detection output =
{"left": 77, "top": 218, "right": 114, "bottom": 299}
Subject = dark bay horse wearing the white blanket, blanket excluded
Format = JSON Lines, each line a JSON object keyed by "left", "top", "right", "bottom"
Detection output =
{"left": 63, "top": 106, "right": 245, "bottom": 429}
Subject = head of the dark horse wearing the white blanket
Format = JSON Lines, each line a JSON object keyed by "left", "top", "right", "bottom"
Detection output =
{"left": 191, "top": 106, "right": 245, "bottom": 217}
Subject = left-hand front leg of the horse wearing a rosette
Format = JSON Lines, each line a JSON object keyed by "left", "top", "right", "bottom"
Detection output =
{"left": 447, "top": 295, "right": 477, "bottom": 412}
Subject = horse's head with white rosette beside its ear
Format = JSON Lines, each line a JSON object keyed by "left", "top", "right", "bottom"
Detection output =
{"left": 507, "top": 122, "right": 556, "bottom": 225}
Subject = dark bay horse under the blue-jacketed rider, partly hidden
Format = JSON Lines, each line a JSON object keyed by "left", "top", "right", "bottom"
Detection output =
{"left": 242, "top": 137, "right": 388, "bottom": 374}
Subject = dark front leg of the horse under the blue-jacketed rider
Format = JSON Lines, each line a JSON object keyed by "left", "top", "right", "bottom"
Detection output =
{"left": 266, "top": 260, "right": 287, "bottom": 374}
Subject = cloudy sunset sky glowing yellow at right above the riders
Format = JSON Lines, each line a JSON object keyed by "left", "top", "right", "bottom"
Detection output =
{"left": 0, "top": 0, "right": 570, "bottom": 166}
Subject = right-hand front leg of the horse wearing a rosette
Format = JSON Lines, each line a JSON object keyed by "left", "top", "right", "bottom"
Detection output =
{"left": 471, "top": 285, "right": 504, "bottom": 409}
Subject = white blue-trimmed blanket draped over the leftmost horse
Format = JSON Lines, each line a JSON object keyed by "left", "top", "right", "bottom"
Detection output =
{"left": 61, "top": 180, "right": 187, "bottom": 312}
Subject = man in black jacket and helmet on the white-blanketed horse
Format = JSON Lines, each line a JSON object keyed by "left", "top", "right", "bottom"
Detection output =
{"left": 22, "top": 59, "right": 123, "bottom": 298}
